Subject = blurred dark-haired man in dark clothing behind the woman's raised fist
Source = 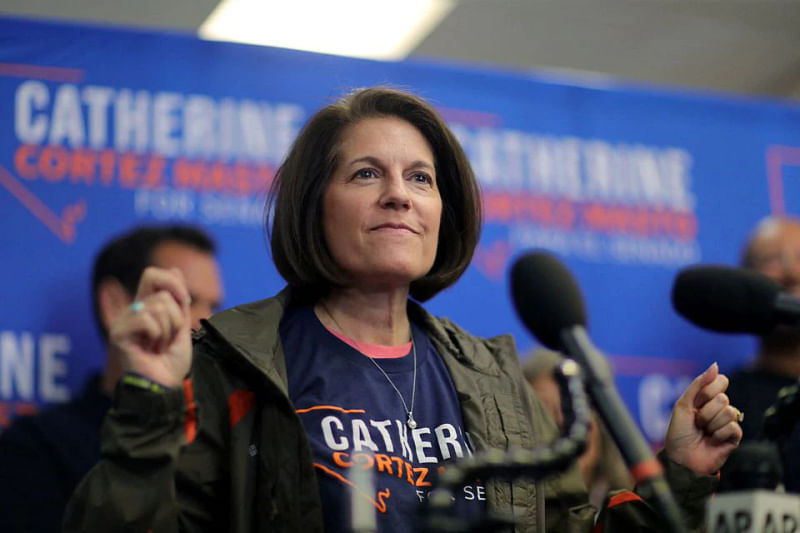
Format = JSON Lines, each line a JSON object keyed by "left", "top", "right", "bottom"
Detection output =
{"left": 0, "top": 225, "right": 223, "bottom": 533}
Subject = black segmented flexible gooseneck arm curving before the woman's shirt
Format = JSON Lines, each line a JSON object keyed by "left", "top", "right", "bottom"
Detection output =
{"left": 421, "top": 359, "right": 591, "bottom": 533}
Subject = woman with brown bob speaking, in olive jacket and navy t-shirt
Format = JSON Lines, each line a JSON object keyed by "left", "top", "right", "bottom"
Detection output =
{"left": 65, "top": 87, "right": 741, "bottom": 533}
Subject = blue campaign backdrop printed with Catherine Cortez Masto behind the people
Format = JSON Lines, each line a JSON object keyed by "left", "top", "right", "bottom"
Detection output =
{"left": 0, "top": 18, "right": 800, "bottom": 443}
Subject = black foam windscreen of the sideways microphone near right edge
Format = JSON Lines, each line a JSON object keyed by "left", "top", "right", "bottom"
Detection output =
{"left": 672, "top": 266, "right": 781, "bottom": 335}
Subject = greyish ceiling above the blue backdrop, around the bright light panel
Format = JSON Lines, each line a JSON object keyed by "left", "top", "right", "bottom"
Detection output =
{"left": 0, "top": 0, "right": 800, "bottom": 100}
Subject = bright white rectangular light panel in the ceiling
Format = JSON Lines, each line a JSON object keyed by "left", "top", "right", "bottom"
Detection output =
{"left": 198, "top": 0, "right": 455, "bottom": 60}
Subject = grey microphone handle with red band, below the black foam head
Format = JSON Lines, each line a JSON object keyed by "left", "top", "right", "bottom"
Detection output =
{"left": 561, "top": 326, "right": 686, "bottom": 533}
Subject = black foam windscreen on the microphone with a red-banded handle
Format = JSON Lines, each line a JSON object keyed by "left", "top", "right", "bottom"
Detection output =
{"left": 511, "top": 252, "right": 586, "bottom": 350}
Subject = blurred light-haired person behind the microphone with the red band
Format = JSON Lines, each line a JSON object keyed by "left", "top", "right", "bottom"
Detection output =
{"left": 522, "top": 348, "right": 633, "bottom": 509}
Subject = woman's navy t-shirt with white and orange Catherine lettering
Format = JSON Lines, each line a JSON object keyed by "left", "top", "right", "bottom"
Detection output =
{"left": 280, "top": 306, "right": 485, "bottom": 533}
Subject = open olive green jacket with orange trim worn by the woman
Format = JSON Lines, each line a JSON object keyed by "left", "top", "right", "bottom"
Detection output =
{"left": 64, "top": 290, "right": 710, "bottom": 533}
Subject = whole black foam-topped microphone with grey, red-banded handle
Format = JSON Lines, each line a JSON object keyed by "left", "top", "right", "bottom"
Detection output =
{"left": 511, "top": 252, "right": 685, "bottom": 531}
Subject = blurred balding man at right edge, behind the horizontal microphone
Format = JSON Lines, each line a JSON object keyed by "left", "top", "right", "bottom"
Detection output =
{"left": 728, "top": 216, "right": 800, "bottom": 492}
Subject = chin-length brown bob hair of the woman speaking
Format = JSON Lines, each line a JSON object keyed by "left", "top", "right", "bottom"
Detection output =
{"left": 268, "top": 87, "right": 481, "bottom": 302}
